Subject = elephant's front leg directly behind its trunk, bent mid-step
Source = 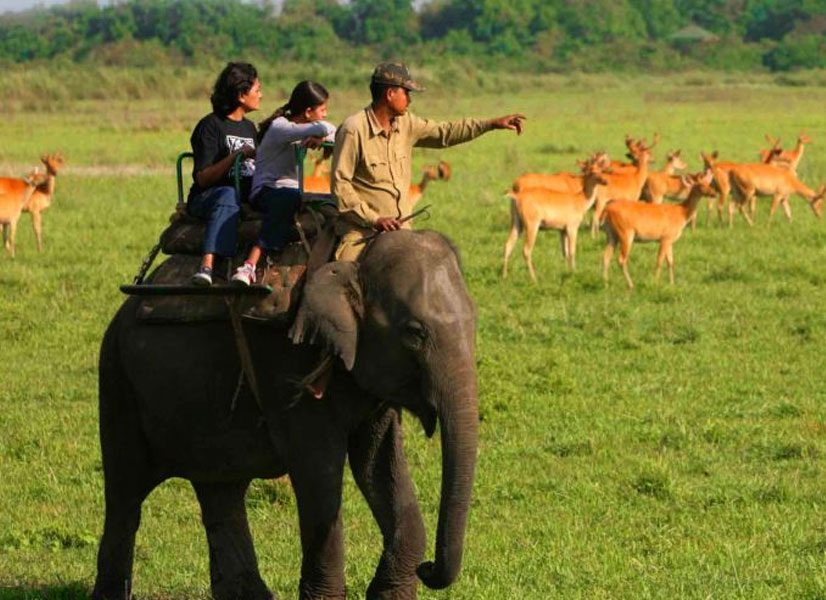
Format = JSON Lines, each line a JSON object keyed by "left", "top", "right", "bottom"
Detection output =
{"left": 349, "top": 409, "right": 426, "bottom": 600}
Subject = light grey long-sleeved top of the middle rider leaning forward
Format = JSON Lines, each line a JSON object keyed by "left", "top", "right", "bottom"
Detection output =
{"left": 250, "top": 117, "right": 336, "bottom": 196}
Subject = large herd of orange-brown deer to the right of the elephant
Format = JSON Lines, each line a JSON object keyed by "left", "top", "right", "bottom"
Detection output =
{"left": 502, "top": 133, "right": 826, "bottom": 288}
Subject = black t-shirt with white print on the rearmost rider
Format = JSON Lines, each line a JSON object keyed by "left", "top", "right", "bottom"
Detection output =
{"left": 189, "top": 113, "right": 256, "bottom": 203}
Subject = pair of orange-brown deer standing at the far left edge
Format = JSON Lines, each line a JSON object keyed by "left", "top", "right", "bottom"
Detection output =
{"left": 0, "top": 153, "right": 64, "bottom": 258}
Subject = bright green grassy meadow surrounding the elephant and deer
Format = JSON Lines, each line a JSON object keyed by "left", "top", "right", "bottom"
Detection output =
{"left": 0, "top": 74, "right": 826, "bottom": 600}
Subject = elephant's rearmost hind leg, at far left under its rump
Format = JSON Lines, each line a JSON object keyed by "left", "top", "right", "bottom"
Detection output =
{"left": 92, "top": 340, "right": 162, "bottom": 600}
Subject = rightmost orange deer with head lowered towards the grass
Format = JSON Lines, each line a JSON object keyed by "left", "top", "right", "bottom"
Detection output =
{"left": 729, "top": 163, "right": 826, "bottom": 224}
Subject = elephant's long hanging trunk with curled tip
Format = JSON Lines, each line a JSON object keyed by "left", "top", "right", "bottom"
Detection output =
{"left": 418, "top": 366, "right": 479, "bottom": 589}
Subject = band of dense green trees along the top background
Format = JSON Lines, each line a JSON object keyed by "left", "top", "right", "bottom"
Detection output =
{"left": 0, "top": 0, "right": 826, "bottom": 71}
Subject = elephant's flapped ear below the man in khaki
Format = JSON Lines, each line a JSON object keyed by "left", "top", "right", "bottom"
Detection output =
{"left": 289, "top": 261, "right": 364, "bottom": 370}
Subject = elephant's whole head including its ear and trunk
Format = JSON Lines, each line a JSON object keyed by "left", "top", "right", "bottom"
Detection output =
{"left": 292, "top": 230, "right": 479, "bottom": 588}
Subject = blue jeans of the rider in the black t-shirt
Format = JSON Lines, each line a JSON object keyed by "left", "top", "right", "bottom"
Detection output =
{"left": 187, "top": 186, "right": 241, "bottom": 257}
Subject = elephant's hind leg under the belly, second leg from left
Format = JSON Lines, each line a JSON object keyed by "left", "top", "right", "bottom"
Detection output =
{"left": 192, "top": 481, "right": 273, "bottom": 600}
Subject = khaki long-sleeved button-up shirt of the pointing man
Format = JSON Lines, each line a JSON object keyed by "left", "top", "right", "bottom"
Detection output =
{"left": 330, "top": 106, "right": 493, "bottom": 226}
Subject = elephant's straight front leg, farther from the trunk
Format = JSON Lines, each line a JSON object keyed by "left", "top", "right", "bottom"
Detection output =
{"left": 289, "top": 412, "right": 347, "bottom": 600}
